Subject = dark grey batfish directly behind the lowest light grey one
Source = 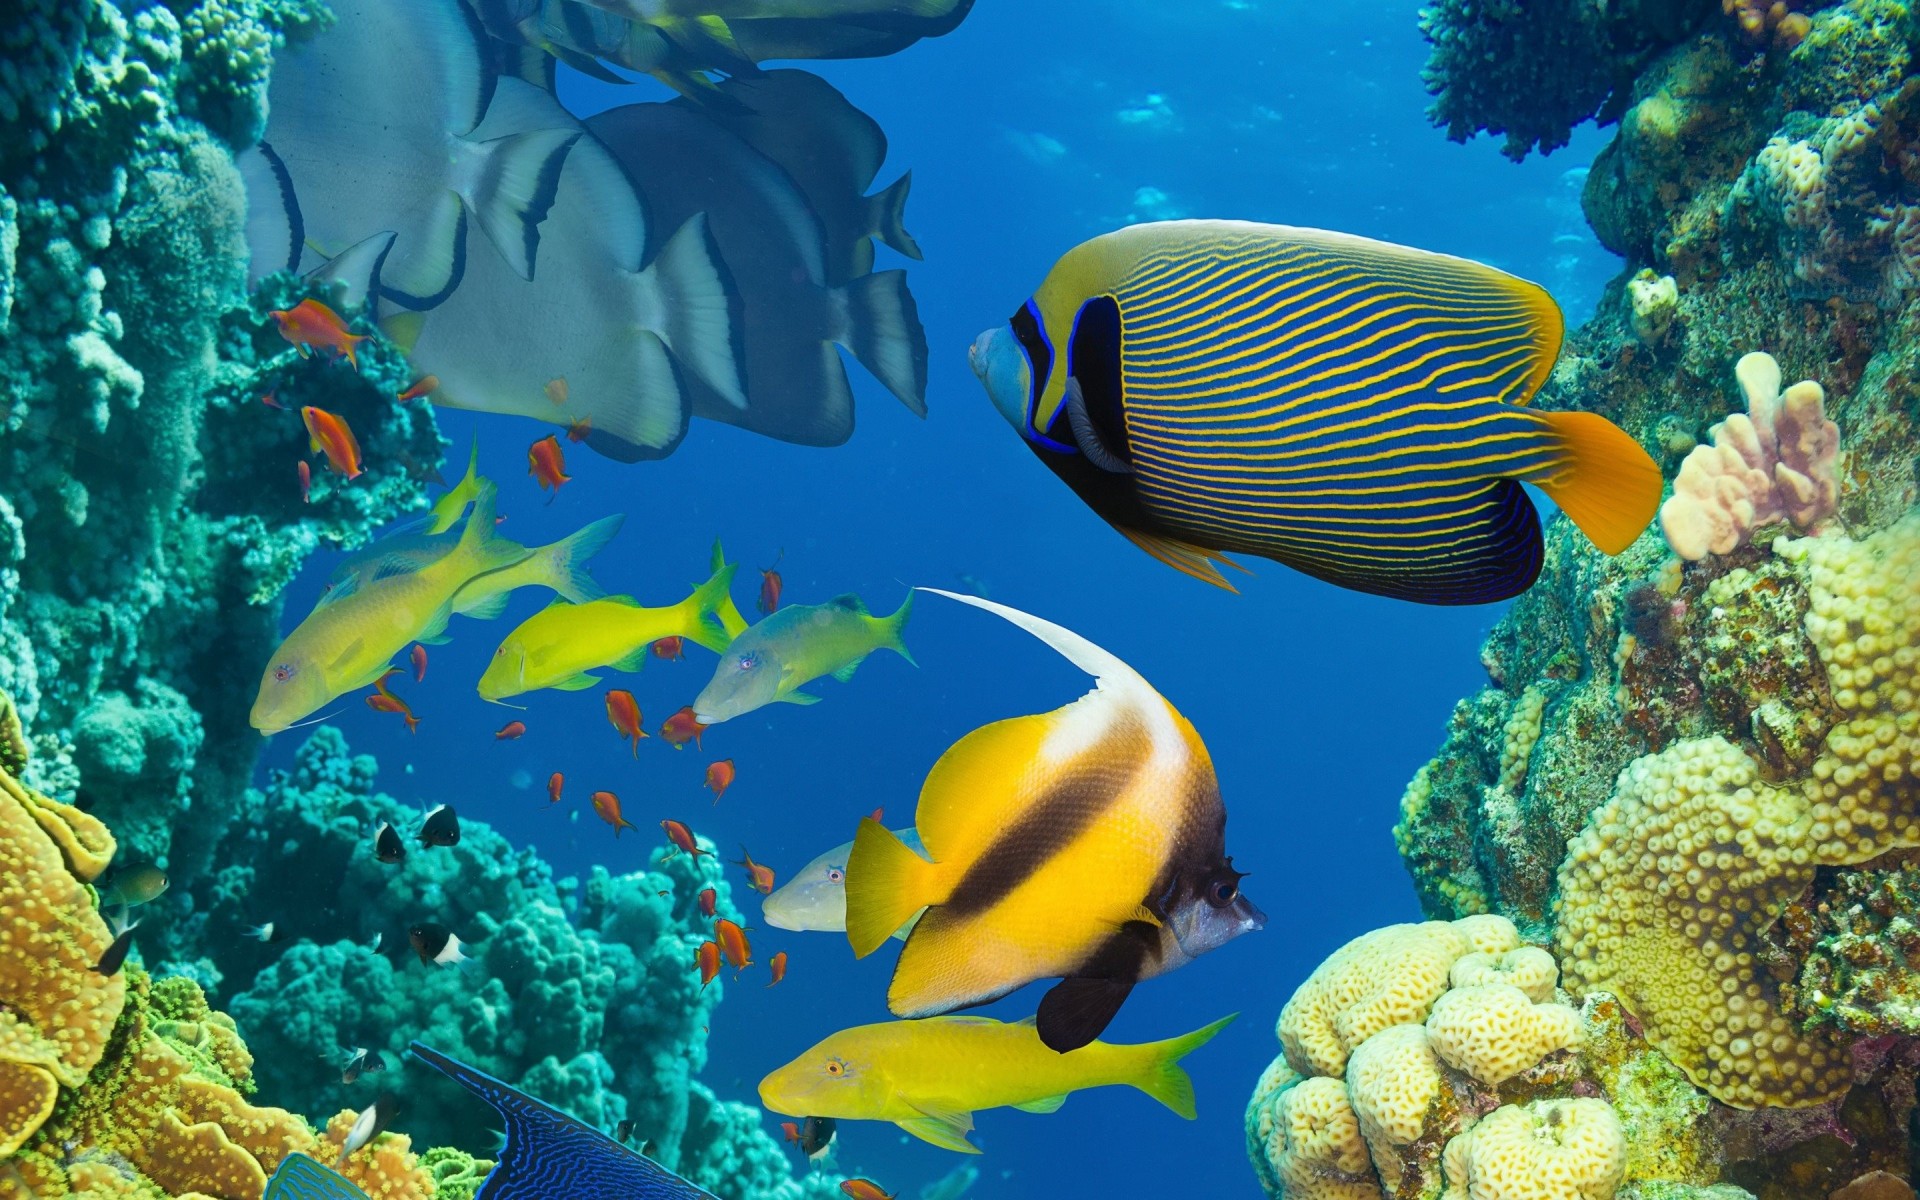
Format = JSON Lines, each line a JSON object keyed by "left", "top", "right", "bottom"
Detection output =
{"left": 588, "top": 104, "right": 927, "bottom": 445}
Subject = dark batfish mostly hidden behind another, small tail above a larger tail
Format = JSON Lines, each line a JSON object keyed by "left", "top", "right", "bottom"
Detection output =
{"left": 674, "top": 70, "right": 922, "bottom": 286}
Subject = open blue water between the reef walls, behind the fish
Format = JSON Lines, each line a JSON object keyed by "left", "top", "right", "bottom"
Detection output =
{"left": 263, "top": 0, "right": 1617, "bottom": 1200}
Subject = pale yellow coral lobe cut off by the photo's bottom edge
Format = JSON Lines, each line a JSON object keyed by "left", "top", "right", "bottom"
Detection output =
{"left": 1442, "top": 1100, "right": 1626, "bottom": 1200}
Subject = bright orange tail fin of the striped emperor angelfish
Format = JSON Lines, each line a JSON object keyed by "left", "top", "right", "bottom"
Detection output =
{"left": 1528, "top": 413, "right": 1663, "bottom": 555}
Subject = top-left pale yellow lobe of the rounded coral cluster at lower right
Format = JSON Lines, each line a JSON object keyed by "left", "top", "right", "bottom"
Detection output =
{"left": 1277, "top": 916, "right": 1521, "bottom": 1075}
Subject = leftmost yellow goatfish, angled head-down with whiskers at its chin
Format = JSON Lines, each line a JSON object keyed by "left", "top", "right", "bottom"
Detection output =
{"left": 250, "top": 484, "right": 528, "bottom": 733}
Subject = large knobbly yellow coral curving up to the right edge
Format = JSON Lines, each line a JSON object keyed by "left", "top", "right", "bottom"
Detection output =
{"left": 1557, "top": 511, "right": 1920, "bottom": 1108}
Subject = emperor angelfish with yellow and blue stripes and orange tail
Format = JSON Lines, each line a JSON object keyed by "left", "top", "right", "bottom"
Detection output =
{"left": 972, "top": 221, "right": 1661, "bottom": 605}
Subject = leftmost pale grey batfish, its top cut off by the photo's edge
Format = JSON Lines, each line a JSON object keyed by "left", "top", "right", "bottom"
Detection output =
{"left": 242, "top": 0, "right": 580, "bottom": 303}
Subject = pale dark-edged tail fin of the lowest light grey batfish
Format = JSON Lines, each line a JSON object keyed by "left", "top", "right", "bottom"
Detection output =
{"left": 639, "top": 213, "right": 747, "bottom": 409}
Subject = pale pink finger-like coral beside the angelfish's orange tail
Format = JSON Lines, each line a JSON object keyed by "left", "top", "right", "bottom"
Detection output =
{"left": 1661, "top": 353, "right": 1839, "bottom": 563}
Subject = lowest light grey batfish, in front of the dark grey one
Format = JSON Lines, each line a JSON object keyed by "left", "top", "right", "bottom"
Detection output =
{"left": 384, "top": 79, "right": 745, "bottom": 463}
